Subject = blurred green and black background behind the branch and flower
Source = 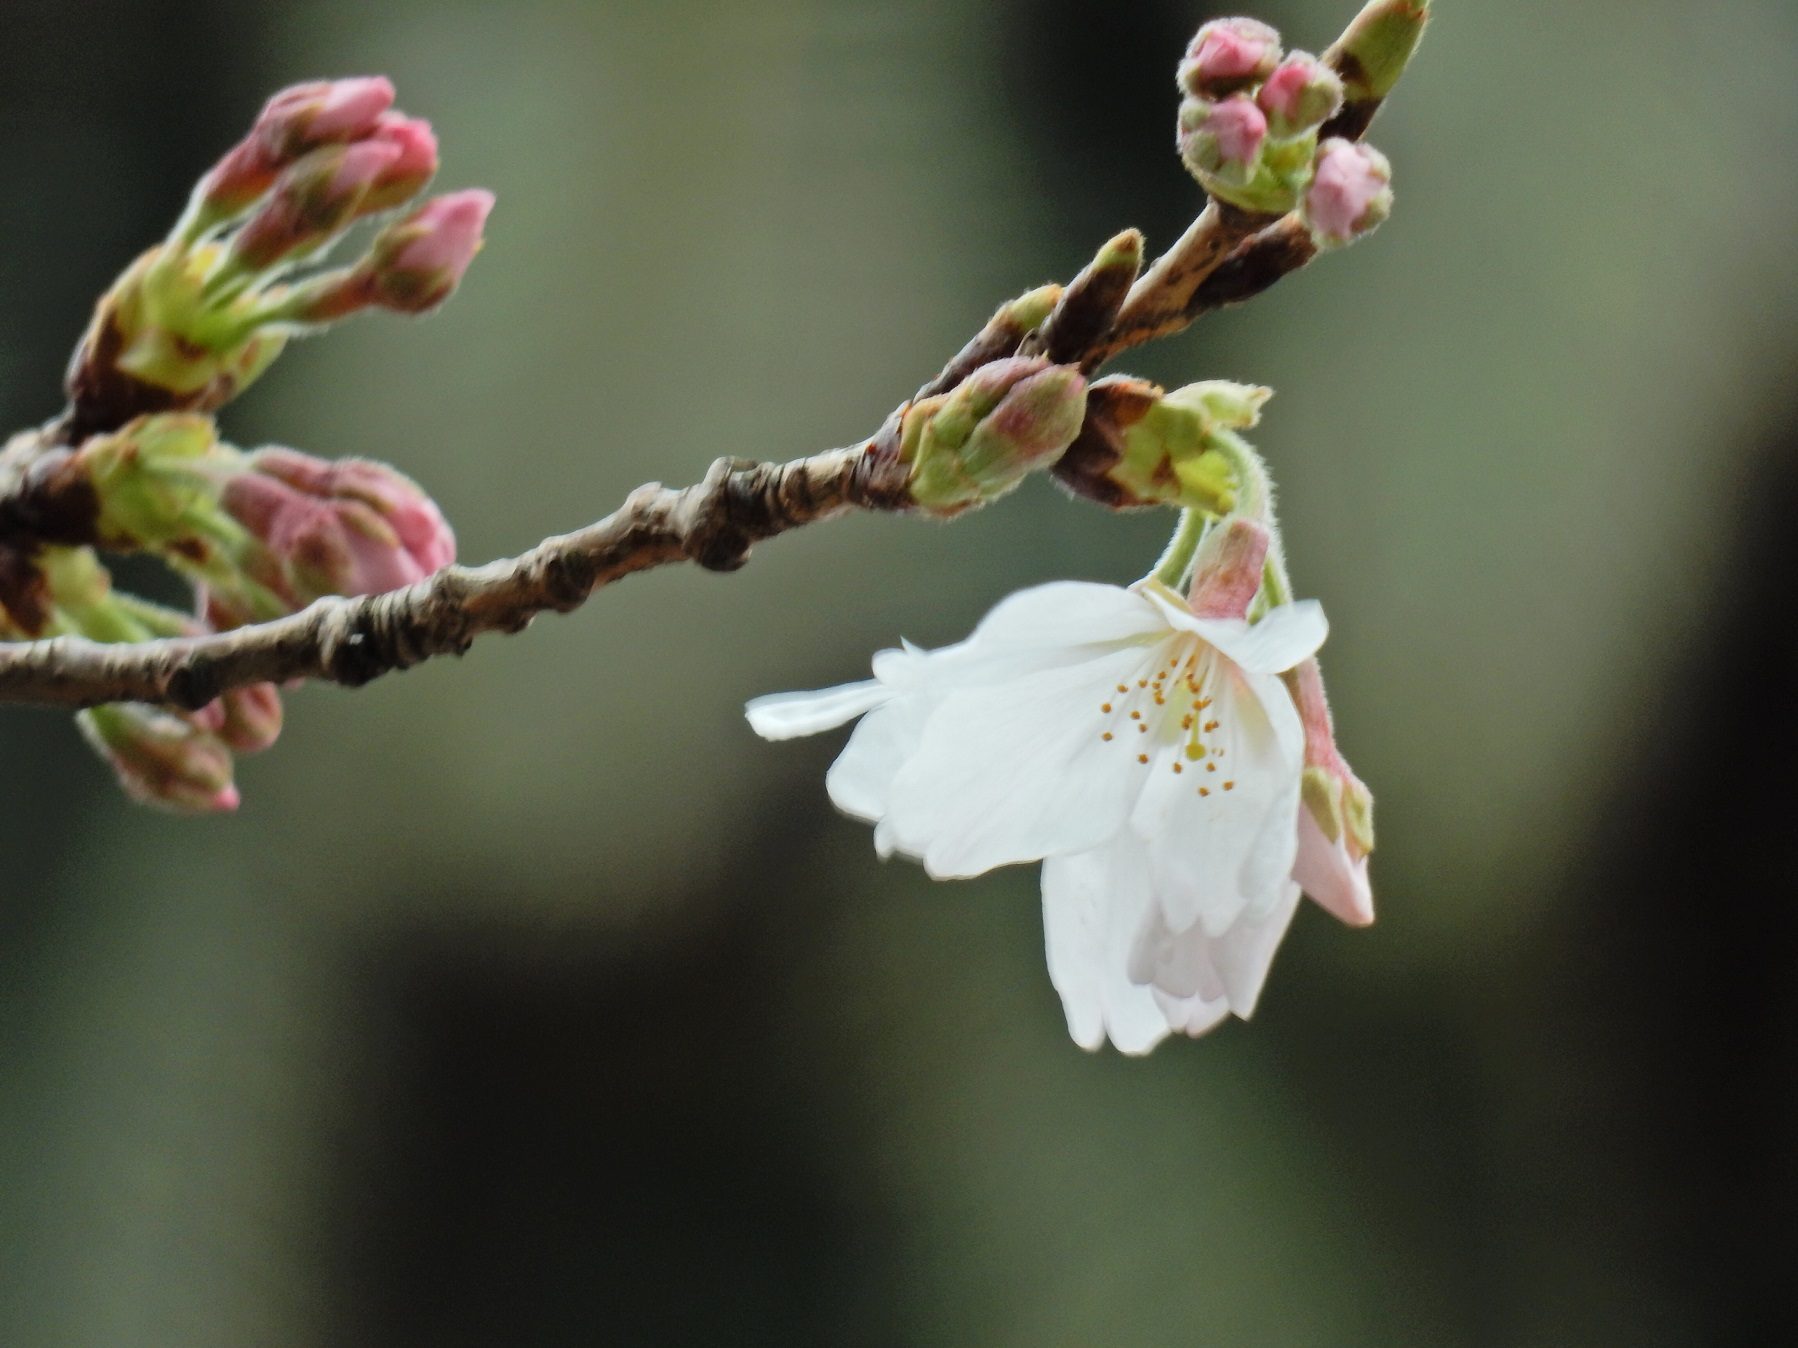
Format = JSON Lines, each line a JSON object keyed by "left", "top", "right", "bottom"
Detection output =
{"left": 0, "top": 0, "right": 1798, "bottom": 1348}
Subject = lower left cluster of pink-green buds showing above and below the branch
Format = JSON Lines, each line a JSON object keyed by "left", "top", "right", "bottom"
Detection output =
{"left": 38, "top": 412, "right": 455, "bottom": 811}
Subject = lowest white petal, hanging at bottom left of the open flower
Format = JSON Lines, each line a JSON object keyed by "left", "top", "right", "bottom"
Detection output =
{"left": 1043, "top": 845, "right": 1169, "bottom": 1053}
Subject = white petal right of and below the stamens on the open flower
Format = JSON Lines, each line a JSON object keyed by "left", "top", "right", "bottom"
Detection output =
{"left": 1129, "top": 665, "right": 1304, "bottom": 936}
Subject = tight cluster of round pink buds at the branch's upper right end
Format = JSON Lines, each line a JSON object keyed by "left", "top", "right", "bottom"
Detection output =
{"left": 1178, "top": 9, "right": 1426, "bottom": 246}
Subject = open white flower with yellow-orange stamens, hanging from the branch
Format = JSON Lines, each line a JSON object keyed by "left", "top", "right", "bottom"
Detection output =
{"left": 748, "top": 581, "right": 1325, "bottom": 1051}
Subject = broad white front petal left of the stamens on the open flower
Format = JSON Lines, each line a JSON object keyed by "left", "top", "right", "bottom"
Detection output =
{"left": 888, "top": 647, "right": 1154, "bottom": 879}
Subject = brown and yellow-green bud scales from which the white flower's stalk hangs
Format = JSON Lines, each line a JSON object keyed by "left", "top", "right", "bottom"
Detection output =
{"left": 1054, "top": 376, "right": 1269, "bottom": 514}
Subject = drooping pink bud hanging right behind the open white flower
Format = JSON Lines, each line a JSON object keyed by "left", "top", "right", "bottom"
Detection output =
{"left": 1282, "top": 660, "right": 1374, "bottom": 927}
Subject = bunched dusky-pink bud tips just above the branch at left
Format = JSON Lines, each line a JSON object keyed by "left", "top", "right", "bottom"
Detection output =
{"left": 223, "top": 449, "right": 455, "bottom": 604}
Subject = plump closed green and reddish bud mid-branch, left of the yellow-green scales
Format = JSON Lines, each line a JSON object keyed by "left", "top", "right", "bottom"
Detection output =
{"left": 899, "top": 356, "right": 1086, "bottom": 516}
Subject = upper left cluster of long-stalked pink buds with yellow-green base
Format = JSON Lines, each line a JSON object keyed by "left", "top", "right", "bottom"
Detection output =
{"left": 68, "top": 79, "right": 493, "bottom": 437}
